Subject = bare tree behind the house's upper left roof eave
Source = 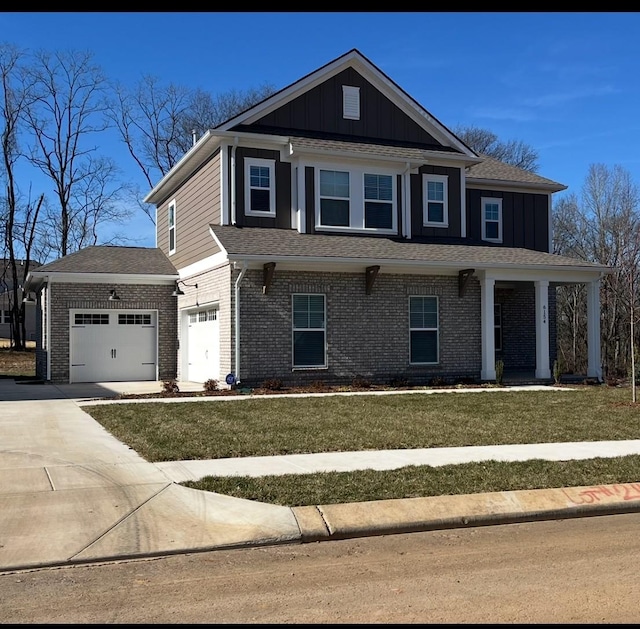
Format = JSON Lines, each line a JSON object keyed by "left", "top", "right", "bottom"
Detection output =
{"left": 107, "top": 75, "right": 275, "bottom": 222}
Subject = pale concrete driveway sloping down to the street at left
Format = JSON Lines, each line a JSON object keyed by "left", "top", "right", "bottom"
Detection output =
{"left": 0, "top": 380, "right": 301, "bottom": 570}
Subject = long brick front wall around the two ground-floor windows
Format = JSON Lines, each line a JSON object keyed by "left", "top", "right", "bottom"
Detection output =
{"left": 233, "top": 267, "right": 481, "bottom": 386}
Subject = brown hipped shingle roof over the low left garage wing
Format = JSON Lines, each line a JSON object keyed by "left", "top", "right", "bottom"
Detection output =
{"left": 31, "top": 245, "right": 178, "bottom": 276}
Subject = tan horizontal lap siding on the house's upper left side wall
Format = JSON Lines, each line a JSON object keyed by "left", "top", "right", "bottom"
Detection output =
{"left": 156, "top": 153, "right": 221, "bottom": 269}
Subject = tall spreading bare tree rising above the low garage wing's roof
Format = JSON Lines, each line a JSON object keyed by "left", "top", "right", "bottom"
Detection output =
{"left": 24, "top": 51, "right": 131, "bottom": 256}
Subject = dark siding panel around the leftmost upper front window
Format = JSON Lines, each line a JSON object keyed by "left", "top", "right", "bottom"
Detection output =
{"left": 236, "top": 148, "right": 291, "bottom": 229}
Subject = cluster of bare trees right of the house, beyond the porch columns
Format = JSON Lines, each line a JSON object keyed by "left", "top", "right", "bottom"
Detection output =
{"left": 554, "top": 164, "right": 640, "bottom": 378}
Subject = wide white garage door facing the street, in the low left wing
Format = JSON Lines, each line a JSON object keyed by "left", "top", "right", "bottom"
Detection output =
{"left": 69, "top": 310, "right": 158, "bottom": 382}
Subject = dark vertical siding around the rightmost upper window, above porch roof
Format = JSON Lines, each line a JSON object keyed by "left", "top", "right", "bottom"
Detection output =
{"left": 467, "top": 189, "right": 549, "bottom": 252}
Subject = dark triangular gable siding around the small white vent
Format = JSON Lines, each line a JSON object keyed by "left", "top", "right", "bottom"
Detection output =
{"left": 247, "top": 68, "right": 441, "bottom": 148}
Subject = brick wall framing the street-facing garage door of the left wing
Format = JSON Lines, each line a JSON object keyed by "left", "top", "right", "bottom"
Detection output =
{"left": 46, "top": 282, "right": 178, "bottom": 383}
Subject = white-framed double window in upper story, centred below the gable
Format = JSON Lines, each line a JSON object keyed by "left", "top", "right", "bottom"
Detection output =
{"left": 316, "top": 167, "right": 397, "bottom": 233}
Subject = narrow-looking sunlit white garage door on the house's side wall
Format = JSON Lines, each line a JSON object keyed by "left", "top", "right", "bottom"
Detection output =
{"left": 187, "top": 308, "right": 220, "bottom": 382}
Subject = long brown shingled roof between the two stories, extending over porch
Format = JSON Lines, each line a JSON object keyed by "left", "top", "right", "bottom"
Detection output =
{"left": 210, "top": 225, "right": 608, "bottom": 271}
